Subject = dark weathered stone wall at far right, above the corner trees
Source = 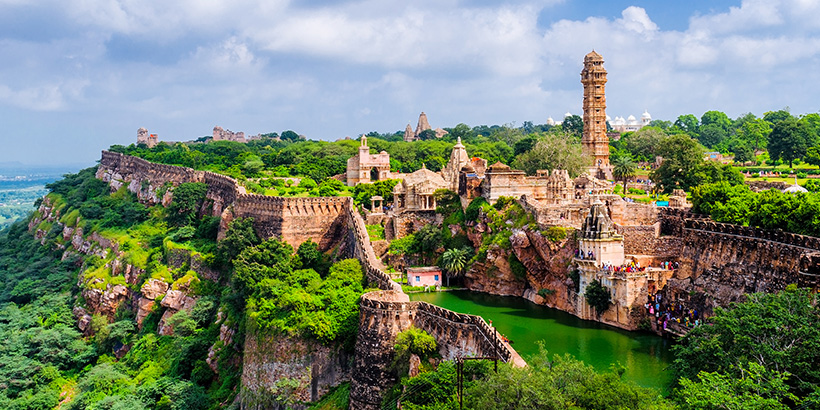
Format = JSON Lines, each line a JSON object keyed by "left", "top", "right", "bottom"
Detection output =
{"left": 661, "top": 210, "right": 820, "bottom": 313}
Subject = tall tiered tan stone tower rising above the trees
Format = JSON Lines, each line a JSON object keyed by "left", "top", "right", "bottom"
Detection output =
{"left": 581, "top": 50, "right": 612, "bottom": 179}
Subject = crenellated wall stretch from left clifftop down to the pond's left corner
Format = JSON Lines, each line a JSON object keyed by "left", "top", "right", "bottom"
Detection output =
{"left": 97, "top": 151, "right": 401, "bottom": 290}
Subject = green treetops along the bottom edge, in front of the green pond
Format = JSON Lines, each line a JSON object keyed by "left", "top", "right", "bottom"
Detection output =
{"left": 401, "top": 350, "right": 675, "bottom": 410}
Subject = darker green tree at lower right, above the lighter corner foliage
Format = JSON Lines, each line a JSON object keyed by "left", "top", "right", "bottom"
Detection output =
{"left": 672, "top": 285, "right": 820, "bottom": 398}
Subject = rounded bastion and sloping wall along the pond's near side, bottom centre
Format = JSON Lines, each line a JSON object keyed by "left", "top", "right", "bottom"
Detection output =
{"left": 350, "top": 291, "right": 526, "bottom": 410}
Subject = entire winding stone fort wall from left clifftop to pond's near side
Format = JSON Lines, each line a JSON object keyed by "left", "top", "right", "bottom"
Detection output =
{"left": 97, "top": 151, "right": 526, "bottom": 410}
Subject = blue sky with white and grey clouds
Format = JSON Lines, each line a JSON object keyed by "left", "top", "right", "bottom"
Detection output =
{"left": 0, "top": 0, "right": 820, "bottom": 166}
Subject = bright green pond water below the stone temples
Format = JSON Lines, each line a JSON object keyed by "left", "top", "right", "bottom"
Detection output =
{"left": 410, "top": 291, "right": 672, "bottom": 390}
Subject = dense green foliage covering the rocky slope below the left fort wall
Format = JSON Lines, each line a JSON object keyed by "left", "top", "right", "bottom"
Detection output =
{"left": 0, "top": 164, "right": 372, "bottom": 410}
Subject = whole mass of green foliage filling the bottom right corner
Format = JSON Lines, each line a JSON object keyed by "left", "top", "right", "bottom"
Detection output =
{"left": 672, "top": 285, "right": 820, "bottom": 409}
